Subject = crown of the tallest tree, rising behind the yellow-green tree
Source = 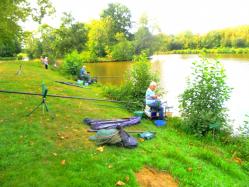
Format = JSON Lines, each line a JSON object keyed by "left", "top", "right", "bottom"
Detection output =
{"left": 101, "top": 3, "right": 131, "bottom": 42}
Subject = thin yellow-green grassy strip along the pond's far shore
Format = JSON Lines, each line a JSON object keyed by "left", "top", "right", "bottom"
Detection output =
{"left": 157, "top": 48, "right": 249, "bottom": 54}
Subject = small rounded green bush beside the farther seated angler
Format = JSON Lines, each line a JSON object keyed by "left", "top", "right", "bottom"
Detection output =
{"left": 62, "top": 51, "right": 82, "bottom": 76}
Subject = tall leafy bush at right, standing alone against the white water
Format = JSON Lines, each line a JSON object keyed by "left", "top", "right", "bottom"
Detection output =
{"left": 180, "top": 57, "right": 231, "bottom": 136}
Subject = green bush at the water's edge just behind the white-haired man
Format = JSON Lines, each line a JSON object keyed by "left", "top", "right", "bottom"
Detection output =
{"left": 105, "top": 53, "right": 158, "bottom": 111}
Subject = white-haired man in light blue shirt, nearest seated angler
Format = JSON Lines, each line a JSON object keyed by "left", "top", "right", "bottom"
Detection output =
{"left": 145, "top": 81, "right": 164, "bottom": 120}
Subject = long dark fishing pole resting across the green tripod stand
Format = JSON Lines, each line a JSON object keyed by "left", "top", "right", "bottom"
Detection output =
{"left": 0, "top": 90, "right": 137, "bottom": 104}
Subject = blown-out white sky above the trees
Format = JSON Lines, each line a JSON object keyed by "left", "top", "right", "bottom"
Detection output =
{"left": 24, "top": 0, "right": 249, "bottom": 34}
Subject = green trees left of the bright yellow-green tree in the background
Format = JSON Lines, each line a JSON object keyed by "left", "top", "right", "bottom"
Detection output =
{"left": 24, "top": 13, "right": 87, "bottom": 59}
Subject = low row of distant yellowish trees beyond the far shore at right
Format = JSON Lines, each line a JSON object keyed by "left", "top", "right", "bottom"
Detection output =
{"left": 160, "top": 25, "right": 249, "bottom": 53}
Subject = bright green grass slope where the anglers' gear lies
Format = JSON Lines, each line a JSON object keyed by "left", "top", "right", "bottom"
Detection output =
{"left": 0, "top": 61, "right": 249, "bottom": 187}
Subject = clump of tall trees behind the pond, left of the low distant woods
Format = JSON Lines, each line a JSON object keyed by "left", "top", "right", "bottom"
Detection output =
{"left": 23, "top": 3, "right": 158, "bottom": 62}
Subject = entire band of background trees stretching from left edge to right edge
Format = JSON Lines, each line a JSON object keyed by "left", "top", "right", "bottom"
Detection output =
{"left": 0, "top": 0, "right": 249, "bottom": 59}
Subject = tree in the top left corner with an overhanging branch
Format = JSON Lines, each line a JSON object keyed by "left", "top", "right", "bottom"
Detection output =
{"left": 0, "top": 0, "right": 54, "bottom": 56}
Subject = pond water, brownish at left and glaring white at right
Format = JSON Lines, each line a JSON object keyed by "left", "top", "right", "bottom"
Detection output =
{"left": 87, "top": 55, "right": 249, "bottom": 128}
